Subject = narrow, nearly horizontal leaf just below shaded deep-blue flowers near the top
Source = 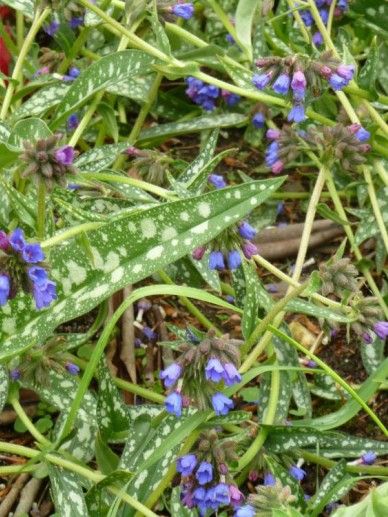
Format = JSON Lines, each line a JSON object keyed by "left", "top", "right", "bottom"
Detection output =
{"left": 137, "top": 113, "right": 248, "bottom": 144}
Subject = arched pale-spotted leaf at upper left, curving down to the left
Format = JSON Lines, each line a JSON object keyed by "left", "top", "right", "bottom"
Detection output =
{"left": 54, "top": 50, "right": 154, "bottom": 127}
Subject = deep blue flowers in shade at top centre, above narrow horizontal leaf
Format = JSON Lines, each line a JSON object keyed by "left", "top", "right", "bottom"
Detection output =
{"left": 185, "top": 77, "right": 240, "bottom": 111}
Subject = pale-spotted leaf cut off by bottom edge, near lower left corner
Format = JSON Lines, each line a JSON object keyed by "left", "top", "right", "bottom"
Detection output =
{"left": 47, "top": 463, "right": 89, "bottom": 517}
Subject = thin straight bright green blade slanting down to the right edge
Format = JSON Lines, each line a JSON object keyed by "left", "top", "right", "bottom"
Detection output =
{"left": 268, "top": 325, "right": 388, "bottom": 436}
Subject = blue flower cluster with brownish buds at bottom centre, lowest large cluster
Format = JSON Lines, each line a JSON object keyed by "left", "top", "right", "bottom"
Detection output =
{"left": 176, "top": 430, "right": 244, "bottom": 515}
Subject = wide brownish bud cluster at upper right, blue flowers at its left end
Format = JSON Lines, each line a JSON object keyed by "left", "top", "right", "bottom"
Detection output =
{"left": 265, "top": 124, "right": 370, "bottom": 174}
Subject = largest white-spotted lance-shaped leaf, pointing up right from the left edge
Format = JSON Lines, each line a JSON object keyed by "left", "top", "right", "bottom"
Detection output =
{"left": 0, "top": 178, "right": 284, "bottom": 360}
